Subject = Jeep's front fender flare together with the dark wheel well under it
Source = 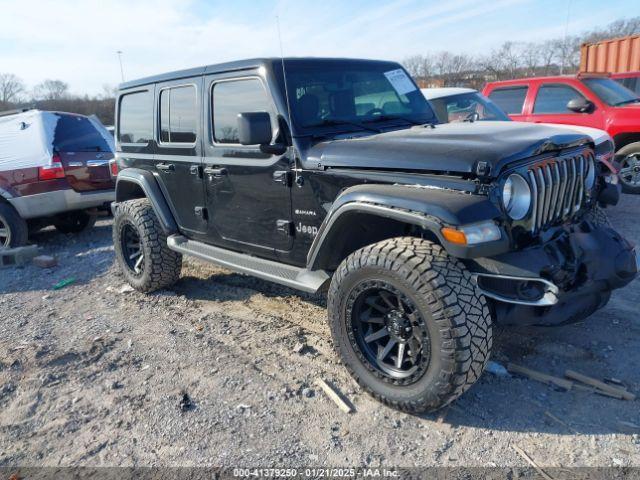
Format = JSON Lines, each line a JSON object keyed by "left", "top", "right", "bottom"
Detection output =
{"left": 307, "top": 185, "right": 508, "bottom": 271}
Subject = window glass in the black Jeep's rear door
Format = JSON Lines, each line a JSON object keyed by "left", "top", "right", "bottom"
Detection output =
{"left": 160, "top": 85, "right": 198, "bottom": 143}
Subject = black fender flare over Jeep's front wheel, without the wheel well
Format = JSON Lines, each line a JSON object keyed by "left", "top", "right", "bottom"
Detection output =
{"left": 307, "top": 185, "right": 509, "bottom": 270}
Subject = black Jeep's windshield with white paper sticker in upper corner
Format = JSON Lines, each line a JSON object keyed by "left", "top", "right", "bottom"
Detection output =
{"left": 287, "top": 62, "right": 436, "bottom": 131}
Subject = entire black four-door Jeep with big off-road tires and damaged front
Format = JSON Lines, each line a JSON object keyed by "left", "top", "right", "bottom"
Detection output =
{"left": 113, "top": 58, "right": 638, "bottom": 412}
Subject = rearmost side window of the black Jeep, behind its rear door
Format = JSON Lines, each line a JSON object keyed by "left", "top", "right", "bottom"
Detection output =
{"left": 118, "top": 91, "right": 153, "bottom": 143}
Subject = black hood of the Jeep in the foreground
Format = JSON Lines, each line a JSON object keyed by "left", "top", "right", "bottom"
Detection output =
{"left": 303, "top": 121, "right": 592, "bottom": 176}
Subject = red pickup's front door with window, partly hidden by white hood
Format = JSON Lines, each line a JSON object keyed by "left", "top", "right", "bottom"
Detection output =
{"left": 529, "top": 82, "right": 604, "bottom": 128}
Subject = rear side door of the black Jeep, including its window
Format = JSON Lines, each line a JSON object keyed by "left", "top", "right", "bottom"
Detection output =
{"left": 154, "top": 77, "right": 206, "bottom": 238}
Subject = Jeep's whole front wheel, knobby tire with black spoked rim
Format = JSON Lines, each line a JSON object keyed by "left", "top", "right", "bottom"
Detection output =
{"left": 328, "top": 237, "right": 492, "bottom": 413}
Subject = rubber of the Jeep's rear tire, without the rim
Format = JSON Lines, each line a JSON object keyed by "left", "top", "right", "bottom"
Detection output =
{"left": 113, "top": 198, "right": 182, "bottom": 292}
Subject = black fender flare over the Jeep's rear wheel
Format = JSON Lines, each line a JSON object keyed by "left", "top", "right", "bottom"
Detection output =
{"left": 115, "top": 168, "right": 178, "bottom": 235}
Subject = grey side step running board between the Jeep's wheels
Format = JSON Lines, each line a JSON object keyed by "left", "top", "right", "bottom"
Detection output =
{"left": 167, "top": 235, "right": 329, "bottom": 293}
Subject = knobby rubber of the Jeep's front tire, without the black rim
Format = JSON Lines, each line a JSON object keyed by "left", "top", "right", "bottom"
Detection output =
{"left": 328, "top": 237, "right": 492, "bottom": 413}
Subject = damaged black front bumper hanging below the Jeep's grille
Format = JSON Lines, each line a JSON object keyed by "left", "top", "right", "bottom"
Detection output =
{"left": 468, "top": 222, "right": 640, "bottom": 325}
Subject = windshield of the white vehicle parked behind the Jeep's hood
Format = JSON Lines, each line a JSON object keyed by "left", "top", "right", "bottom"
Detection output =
{"left": 429, "top": 92, "right": 511, "bottom": 123}
